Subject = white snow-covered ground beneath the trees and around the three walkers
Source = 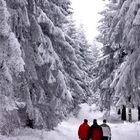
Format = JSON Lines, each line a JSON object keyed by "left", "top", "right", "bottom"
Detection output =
{"left": 0, "top": 104, "right": 140, "bottom": 140}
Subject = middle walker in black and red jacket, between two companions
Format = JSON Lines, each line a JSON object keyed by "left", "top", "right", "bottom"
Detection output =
{"left": 88, "top": 119, "right": 103, "bottom": 140}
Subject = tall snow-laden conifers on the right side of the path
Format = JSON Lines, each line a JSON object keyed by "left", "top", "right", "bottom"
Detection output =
{"left": 97, "top": 0, "right": 140, "bottom": 111}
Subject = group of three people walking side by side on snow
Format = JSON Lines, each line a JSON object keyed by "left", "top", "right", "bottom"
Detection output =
{"left": 78, "top": 119, "right": 111, "bottom": 140}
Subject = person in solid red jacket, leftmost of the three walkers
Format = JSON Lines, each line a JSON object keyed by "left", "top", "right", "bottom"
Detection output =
{"left": 78, "top": 119, "right": 89, "bottom": 140}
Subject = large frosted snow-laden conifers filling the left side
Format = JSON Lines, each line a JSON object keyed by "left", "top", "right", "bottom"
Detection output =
{"left": 0, "top": 0, "right": 97, "bottom": 134}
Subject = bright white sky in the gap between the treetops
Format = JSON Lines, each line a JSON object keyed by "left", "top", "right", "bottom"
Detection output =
{"left": 71, "top": 0, "right": 104, "bottom": 42}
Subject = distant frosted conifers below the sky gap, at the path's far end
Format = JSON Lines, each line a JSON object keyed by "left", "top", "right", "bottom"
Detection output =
{"left": 64, "top": 18, "right": 99, "bottom": 103}
